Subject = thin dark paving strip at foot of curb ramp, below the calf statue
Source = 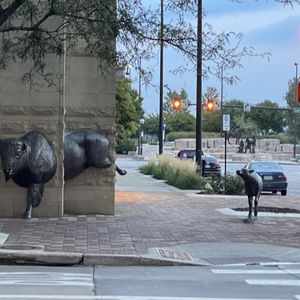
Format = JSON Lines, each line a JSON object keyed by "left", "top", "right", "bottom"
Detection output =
{"left": 202, "top": 256, "right": 277, "bottom": 265}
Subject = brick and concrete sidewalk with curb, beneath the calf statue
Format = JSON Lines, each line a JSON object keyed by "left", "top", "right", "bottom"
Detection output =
{"left": 0, "top": 163, "right": 300, "bottom": 265}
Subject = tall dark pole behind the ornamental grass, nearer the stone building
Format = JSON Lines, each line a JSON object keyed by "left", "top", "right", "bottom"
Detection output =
{"left": 158, "top": 0, "right": 164, "bottom": 154}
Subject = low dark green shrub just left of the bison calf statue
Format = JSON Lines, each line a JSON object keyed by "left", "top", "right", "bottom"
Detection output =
{"left": 209, "top": 175, "right": 244, "bottom": 195}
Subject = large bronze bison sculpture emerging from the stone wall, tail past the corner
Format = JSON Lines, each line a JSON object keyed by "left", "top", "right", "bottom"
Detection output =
{"left": 0, "top": 129, "right": 126, "bottom": 219}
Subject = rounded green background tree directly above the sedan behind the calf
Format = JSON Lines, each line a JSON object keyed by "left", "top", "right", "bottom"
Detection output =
{"left": 247, "top": 100, "right": 284, "bottom": 135}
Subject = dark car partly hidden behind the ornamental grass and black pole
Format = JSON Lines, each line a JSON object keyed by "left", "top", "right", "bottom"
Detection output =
{"left": 177, "top": 149, "right": 221, "bottom": 176}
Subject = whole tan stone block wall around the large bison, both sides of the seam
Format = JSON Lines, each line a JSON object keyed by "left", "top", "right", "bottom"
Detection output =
{"left": 0, "top": 54, "right": 115, "bottom": 217}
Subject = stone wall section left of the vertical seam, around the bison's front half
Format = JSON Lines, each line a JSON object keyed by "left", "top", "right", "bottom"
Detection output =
{"left": 0, "top": 55, "right": 63, "bottom": 217}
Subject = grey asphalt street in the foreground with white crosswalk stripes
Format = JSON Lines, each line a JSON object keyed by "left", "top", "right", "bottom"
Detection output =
{"left": 0, "top": 264, "right": 300, "bottom": 300}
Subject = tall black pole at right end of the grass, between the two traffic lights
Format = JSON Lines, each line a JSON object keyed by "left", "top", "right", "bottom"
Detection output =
{"left": 196, "top": 0, "right": 203, "bottom": 175}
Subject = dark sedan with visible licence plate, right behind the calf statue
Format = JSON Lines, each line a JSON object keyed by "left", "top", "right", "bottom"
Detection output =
{"left": 245, "top": 161, "right": 288, "bottom": 196}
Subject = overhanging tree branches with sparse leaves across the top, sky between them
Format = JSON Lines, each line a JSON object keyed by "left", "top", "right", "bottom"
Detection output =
{"left": 0, "top": 0, "right": 300, "bottom": 83}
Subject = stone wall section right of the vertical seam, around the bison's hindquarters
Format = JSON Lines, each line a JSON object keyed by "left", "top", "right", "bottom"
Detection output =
{"left": 64, "top": 54, "right": 115, "bottom": 214}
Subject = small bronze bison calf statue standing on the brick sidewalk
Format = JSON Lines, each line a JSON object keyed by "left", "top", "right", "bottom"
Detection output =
{"left": 236, "top": 169, "right": 263, "bottom": 223}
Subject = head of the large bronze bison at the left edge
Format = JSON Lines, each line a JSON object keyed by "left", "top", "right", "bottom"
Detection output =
{"left": 0, "top": 139, "right": 27, "bottom": 181}
